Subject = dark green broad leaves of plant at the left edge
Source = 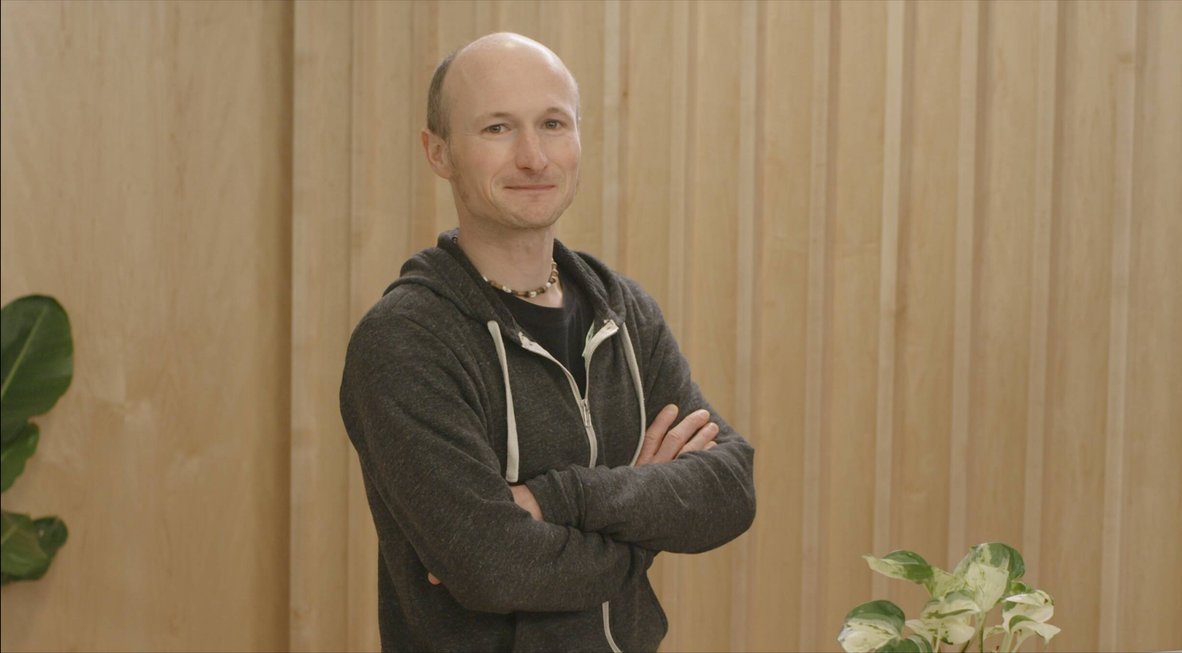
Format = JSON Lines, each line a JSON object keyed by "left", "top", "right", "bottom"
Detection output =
{"left": 0, "top": 295, "right": 73, "bottom": 584}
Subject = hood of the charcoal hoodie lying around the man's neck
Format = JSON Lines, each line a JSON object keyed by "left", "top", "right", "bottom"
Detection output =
{"left": 382, "top": 229, "right": 624, "bottom": 343}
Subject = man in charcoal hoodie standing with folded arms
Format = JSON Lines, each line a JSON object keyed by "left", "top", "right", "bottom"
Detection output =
{"left": 340, "top": 33, "right": 755, "bottom": 651}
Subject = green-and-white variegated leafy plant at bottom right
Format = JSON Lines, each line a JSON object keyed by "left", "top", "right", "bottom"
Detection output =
{"left": 837, "top": 543, "right": 1059, "bottom": 653}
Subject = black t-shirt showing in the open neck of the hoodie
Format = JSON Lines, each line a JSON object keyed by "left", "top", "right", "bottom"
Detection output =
{"left": 499, "top": 267, "right": 591, "bottom": 394}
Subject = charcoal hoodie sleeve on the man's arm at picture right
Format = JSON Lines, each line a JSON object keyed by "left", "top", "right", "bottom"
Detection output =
{"left": 527, "top": 284, "right": 755, "bottom": 554}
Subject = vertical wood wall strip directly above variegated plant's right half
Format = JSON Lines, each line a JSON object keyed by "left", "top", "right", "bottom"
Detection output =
{"left": 973, "top": 2, "right": 1053, "bottom": 560}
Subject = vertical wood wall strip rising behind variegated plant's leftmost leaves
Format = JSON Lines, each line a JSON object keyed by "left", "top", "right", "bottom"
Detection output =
{"left": 812, "top": 2, "right": 887, "bottom": 648}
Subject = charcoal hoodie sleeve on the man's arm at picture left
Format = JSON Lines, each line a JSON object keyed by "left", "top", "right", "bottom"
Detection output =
{"left": 340, "top": 298, "right": 652, "bottom": 613}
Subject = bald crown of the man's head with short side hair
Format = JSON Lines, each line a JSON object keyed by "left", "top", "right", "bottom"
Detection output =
{"left": 427, "top": 32, "right": 579, "bottom": 141}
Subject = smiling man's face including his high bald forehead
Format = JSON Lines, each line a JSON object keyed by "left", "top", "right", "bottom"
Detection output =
{"left": 441, "top": 44, "right": 582, "bottom": 229}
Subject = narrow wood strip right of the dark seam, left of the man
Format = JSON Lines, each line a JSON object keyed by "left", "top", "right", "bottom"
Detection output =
{"left": 288, "top": 2, "right": 353, "bottom": 651}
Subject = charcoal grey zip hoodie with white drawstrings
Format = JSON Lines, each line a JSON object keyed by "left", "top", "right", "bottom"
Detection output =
{"left": 340, "top": 232, "right": 755, "bottom": 651}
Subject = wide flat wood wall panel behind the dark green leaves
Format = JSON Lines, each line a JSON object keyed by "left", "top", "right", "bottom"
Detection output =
{"left": 0, "top": 2, "right": 292, "bottom": 651}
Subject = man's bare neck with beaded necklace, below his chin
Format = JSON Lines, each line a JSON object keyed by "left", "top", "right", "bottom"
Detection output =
{"left": 456, "top": 225, "right": 563, "bottom": 308}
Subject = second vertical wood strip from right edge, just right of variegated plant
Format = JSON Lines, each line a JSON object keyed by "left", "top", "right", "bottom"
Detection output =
{"left": 1040, "top": 2, "right": 1123, "bottom": 651}
